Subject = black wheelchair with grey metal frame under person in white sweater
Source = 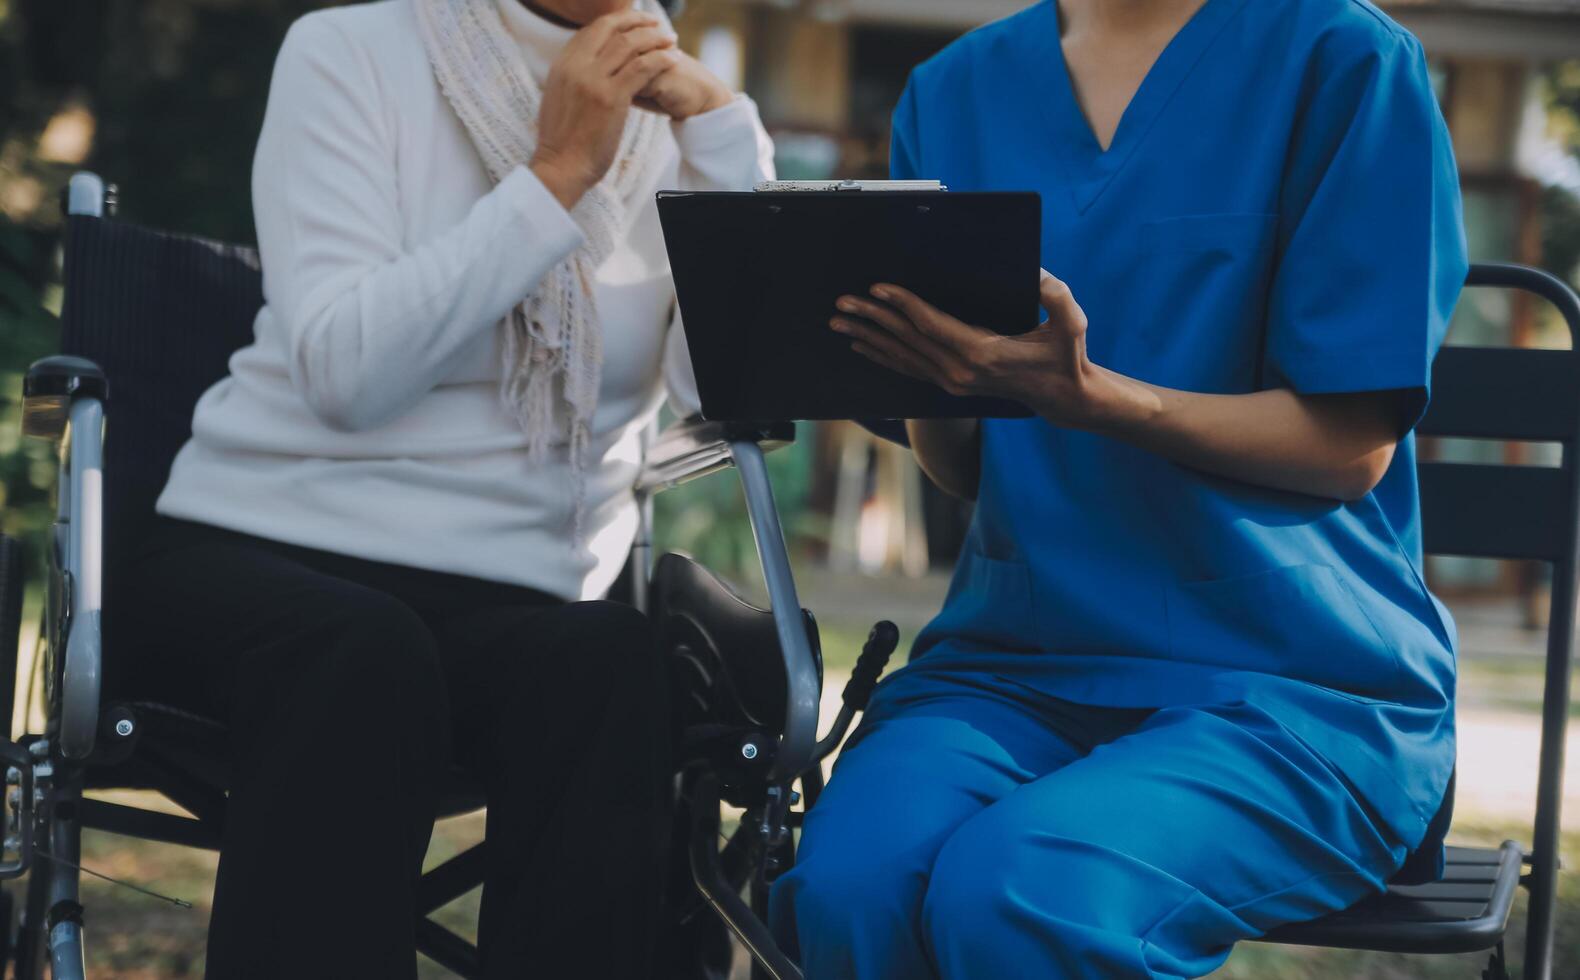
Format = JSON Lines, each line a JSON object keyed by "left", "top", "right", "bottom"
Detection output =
{"left": 0, "top": 174, "right": 897, "bottom": 980}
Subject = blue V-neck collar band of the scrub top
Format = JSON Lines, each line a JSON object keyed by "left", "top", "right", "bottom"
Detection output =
{"left": 1029, "top": 0, "right": 1247, "bottom": 212}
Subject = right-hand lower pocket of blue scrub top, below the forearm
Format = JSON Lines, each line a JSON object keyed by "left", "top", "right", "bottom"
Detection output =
{"left": 1168, "top": 564, "right": 1403, "bottom": 699}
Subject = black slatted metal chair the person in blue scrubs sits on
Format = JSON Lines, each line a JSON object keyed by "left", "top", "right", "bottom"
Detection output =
{"left": 1266, "top": 264, "right": 1580, "bottom": 980}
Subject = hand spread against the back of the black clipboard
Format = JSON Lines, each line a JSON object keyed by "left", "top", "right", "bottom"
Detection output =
{"left": 830, "top": 270, "right": 1117, "bottom": 427}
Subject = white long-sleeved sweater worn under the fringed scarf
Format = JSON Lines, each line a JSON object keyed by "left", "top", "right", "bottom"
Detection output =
{"left": 158, "top": 0, "right": 773, "bottom": 599}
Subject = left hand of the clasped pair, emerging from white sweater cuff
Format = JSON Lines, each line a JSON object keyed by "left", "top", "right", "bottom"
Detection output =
{"left": 529, "top": 9, "right": 676, "bottom": 210}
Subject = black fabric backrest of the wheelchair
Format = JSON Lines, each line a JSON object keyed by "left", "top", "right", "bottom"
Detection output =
{"left": 62, "top": 215, "right": 264, "bottom": 582}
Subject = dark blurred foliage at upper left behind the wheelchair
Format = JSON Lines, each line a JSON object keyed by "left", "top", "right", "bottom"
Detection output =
{"left": 0, "top": 0, "right": 347, "bottom": 556}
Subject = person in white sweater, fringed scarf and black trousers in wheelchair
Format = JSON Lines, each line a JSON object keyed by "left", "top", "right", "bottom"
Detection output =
{"left": 123, "top": 0, "right": 771, "bottom": 980}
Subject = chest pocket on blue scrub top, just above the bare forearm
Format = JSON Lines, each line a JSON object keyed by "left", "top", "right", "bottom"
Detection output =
{"left": 1131, "top": 213, "right": 1278, "bottom": 394}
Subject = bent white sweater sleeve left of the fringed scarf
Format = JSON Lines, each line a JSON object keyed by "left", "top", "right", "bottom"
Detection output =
{"left": 253, "top": 14, "right": 583, "bottom": 430}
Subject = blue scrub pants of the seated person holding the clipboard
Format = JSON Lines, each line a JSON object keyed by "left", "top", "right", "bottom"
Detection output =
{"left": 771, "top": 669, "right": 1406, "bottom": 980}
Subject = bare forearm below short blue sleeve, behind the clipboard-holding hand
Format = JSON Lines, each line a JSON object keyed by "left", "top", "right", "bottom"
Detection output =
{"left": 1084, "top": 368, "right": 1400, "bottom": 501}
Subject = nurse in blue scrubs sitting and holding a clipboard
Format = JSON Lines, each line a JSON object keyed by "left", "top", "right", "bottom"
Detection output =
{"left": 773, "top": 0, "right": 1466, "bottom": 980}
